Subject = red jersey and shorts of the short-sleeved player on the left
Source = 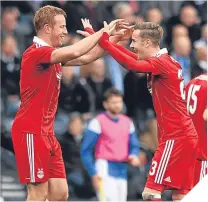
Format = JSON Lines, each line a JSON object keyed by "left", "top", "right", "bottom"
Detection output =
{"left": 12, "top": 37, "right": 66, "bottom": 183}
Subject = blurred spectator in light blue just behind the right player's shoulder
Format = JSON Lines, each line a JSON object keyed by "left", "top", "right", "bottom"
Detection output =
{"left": 171, "top": 37, "right": 192, "bottom": 84}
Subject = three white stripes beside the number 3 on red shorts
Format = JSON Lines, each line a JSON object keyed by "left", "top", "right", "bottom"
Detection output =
{"left": 155, "top": 140, "right": 174, "bottom": 184}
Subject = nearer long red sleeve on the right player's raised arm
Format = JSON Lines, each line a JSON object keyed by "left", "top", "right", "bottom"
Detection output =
{"left": 100, "top": 33, "right": 159, "bottom": 74}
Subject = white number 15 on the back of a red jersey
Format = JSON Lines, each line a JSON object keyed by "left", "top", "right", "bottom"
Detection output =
{"left": 187, "top": 84, "right": 201, "bottom": 114}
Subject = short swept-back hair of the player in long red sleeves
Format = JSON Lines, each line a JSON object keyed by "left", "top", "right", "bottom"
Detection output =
{"left": 134, "top": 22, "right": 163, "bottom": 45}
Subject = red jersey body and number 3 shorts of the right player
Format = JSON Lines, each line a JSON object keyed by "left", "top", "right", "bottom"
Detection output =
{"left": 146, "top": 49, "right": 198, "bottom": 194}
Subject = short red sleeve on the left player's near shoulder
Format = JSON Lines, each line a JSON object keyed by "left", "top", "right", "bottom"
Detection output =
{"left": 34, "top": 46, "right": 55, "bottom": 64}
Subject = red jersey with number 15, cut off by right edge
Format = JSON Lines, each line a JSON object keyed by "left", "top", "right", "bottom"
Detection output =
{"left": 186, "top": 74, "right": 208, "bottom": 160}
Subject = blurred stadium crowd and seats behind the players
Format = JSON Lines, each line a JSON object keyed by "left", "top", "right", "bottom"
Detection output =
{"left": 0, "top": 0, "right": 207, "bottom": 201}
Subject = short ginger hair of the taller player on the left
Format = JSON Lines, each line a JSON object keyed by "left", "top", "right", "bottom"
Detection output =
{"left": 34, "top": 5, "right": 67, "bottom": 32}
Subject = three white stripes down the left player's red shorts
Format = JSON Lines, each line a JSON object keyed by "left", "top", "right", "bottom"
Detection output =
{"left": 27, "top": 134, "right": 35, "bottom": 183}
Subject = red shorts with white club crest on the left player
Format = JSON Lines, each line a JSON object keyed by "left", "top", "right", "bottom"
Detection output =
{"left": 12, "top": 130, "right": 66, "bottom": 184}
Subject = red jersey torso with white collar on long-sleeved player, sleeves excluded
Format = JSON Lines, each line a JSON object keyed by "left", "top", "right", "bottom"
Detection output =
{"left": 146, "top": 49, "right": 197, "bottom": 142}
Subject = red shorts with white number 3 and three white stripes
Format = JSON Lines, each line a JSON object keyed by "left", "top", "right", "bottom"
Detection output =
{"left": 145, "top": 139, "right": 198, "bottom": 194}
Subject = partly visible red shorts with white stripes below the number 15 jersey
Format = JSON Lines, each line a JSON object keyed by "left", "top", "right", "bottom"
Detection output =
{"left": 194, "top": 160, "right": 208, "bottom": 186}
